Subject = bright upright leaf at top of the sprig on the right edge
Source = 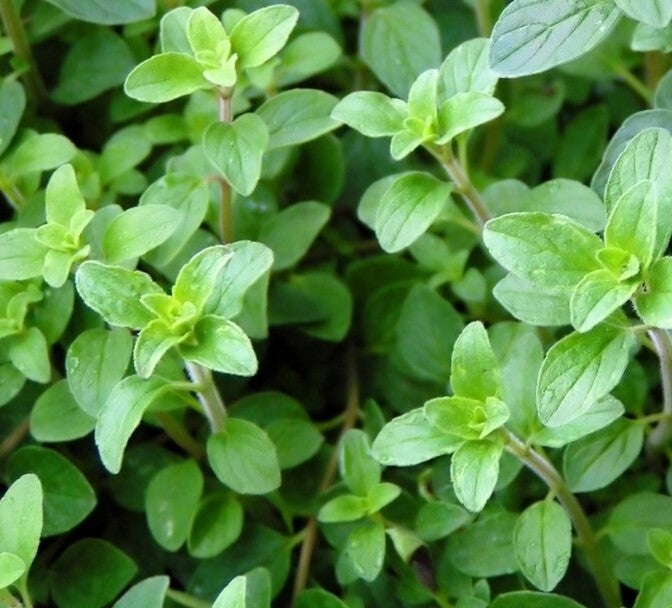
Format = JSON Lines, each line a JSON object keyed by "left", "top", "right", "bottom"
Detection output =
{"left": 604, "top": 180, "right": 658, "bottom": 270}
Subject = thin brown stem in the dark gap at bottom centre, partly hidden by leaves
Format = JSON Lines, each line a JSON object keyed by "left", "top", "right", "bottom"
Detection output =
{"left": 292, "top": 341, "right": 359, "bottom": 604}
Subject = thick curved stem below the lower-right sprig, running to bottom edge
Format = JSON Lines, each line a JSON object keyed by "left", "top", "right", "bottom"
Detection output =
{"left": 504, "top": 430, "right": 622, "bottom": 608}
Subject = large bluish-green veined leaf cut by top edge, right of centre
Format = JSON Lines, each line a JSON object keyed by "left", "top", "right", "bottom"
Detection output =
{"left": 490, "top": 0, "right": 621, "bottom": 77}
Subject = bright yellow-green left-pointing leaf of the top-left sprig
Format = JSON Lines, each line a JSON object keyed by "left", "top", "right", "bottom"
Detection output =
{"left": 124, "top": 52, "right": 207, "bottom": 103}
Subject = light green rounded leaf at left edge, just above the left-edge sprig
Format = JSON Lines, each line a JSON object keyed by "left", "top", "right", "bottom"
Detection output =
{"left": 7, "top": 133, "right": 77, "bottom": 177}
